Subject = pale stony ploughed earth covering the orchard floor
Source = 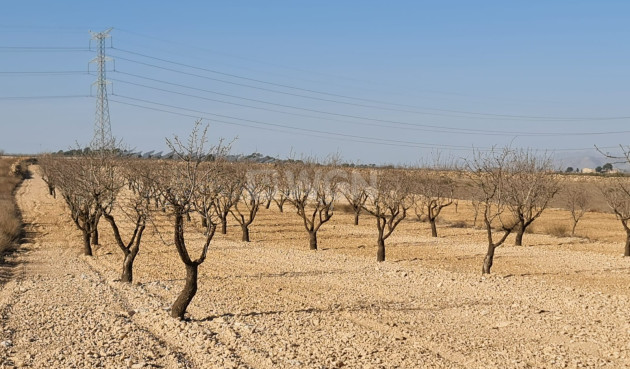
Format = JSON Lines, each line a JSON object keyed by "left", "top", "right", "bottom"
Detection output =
{"left": 0, "top": 167, "right": 630, "bottom": 368}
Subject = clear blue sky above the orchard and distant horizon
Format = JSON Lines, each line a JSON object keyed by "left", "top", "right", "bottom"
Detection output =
{"left": 0, "top": 0, "right": 630, "bottom": 164}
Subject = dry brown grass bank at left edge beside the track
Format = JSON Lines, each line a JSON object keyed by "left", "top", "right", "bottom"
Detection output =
{"left": 0, "top": 158, "right": 22, "bottom": 253}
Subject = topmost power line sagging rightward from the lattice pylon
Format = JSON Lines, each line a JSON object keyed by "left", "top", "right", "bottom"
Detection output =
{"left": 114, "top": 48, "right": 630, "bottom": 121}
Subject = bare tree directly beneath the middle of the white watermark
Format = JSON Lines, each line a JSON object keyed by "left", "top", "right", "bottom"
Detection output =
{"left": 285, "top": 162, "right": 345, "bottom": 250}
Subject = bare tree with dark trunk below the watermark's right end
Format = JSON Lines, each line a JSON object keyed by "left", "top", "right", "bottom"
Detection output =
{"left": 363, "top": 169, "right": 412, "bottom": 261}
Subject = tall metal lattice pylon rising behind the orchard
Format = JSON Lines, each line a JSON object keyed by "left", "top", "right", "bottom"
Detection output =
{"left": 90, "top": 28, "right": 114, "bottom": 151}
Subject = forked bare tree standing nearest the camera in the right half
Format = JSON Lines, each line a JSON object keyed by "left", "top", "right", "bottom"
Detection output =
{"left": 466, "top": 148, "right": 517, "bottom": 274}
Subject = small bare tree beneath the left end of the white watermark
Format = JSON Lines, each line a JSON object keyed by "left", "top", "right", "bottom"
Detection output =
{"left": 230, "top": 166, "right": 266, "bottom": 242}
